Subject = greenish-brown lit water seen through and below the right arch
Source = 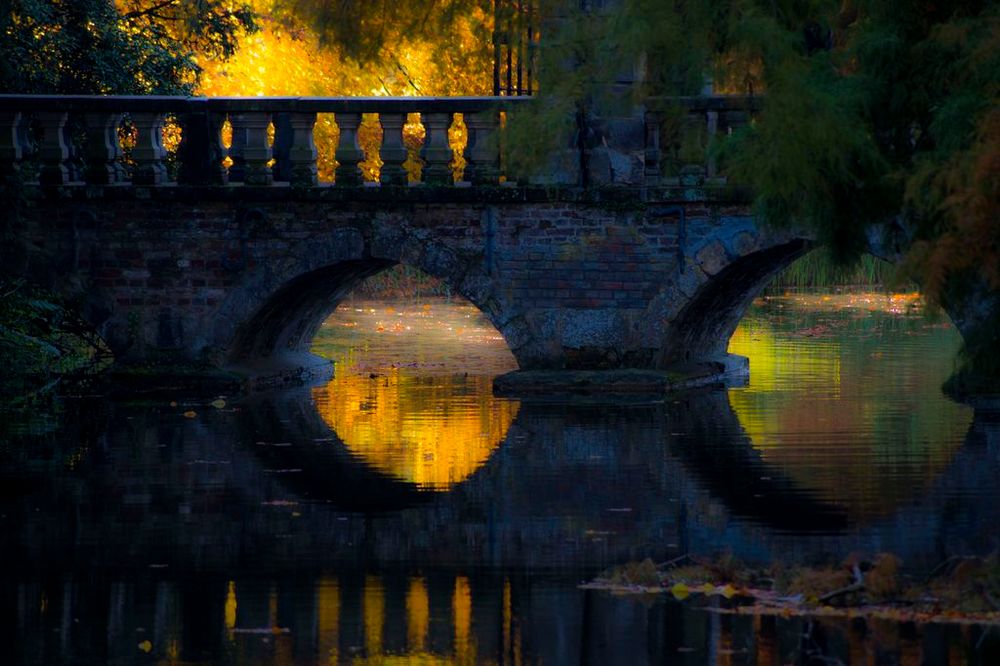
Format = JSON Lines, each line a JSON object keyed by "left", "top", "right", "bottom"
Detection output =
{"left": 729, "top": 293, "right": 972, "bottom": 519}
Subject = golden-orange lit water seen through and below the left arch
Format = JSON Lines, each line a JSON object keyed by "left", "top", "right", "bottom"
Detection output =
{"left": 313, "top": 302, "right": 519, "bottom": 490}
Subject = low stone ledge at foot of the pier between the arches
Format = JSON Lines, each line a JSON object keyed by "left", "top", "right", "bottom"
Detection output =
{"left": 493, "top": 354, "right": 750, "bottom": 402}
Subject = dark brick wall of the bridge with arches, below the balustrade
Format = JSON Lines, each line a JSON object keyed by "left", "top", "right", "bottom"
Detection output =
{"left": 6, "top": 183, "right": 806, "bottom": 378}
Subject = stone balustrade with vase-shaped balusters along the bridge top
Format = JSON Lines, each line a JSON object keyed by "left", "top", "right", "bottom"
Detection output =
{"left": 0, "top": 95, "right": 754, "bottom": 187}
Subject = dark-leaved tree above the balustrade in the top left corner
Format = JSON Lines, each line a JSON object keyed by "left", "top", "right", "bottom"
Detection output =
{"left": 0, "top": 0, "right": 257, "bottom": 94}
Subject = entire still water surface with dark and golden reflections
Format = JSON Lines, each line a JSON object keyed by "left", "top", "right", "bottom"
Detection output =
{"left": 0, "top": 294, "right": 1000, "bottom": 664}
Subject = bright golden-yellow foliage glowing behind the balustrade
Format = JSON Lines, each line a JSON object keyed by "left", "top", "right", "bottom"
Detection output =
{"left": 190, "top": 0, "right": 491, "bottom": 182}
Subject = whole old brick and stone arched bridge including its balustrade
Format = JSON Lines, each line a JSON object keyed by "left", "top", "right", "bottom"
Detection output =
{"left": 0, "top": 96, "right": 900, "bottom": 384}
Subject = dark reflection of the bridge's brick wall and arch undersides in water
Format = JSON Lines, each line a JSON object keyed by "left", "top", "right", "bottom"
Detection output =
{"left": 0, "top": 392, "right": 1000, "bottom": 573}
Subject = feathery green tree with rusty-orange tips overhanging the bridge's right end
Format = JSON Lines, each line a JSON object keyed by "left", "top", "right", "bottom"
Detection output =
{"left": 512, "top": 0, "right": 1000, "bottom": 381}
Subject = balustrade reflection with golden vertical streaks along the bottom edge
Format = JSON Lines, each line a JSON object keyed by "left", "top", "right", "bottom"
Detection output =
{"left": 0, "top": 556, "right": 997, "bottom": 666}
